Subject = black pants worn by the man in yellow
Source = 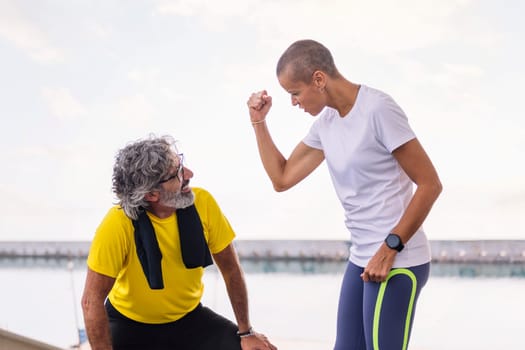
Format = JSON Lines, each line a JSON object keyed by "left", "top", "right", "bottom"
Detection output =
{"left": 106, "top": 300, "right": 241, "bottom": 350}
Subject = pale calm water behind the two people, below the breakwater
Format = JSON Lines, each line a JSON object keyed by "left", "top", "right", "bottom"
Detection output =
{"left": 0, "top": 259, "right": 525, "bottom": 350}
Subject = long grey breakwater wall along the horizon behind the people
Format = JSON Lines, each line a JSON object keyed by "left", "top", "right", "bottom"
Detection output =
{"left": 0, "top": 239, "right": 525, "bottom": 263}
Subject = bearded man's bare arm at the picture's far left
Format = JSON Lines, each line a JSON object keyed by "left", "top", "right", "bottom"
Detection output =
{"left": 82, "top": 268, "right": 115, "bottom": 350}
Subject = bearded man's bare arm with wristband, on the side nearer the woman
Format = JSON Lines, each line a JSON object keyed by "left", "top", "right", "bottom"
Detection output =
{"left": 213, "top": 244, "right": 277, "bottom": 350}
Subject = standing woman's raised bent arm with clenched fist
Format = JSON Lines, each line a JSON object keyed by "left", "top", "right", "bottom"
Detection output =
{"left": 247, "top": 90, "right": 324, "bottom": 192}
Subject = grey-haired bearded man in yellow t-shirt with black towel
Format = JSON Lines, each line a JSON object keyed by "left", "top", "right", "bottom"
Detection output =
{"left": 82, "top": 137, "right": 276, "bottom": 350}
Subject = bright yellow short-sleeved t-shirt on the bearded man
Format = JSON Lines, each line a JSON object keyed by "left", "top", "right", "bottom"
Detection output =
{"left": 87, "top": 188, "right": 235, "bottom": 324}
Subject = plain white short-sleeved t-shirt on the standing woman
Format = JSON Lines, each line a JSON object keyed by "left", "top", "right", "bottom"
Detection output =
{"left": 303, "top": 85, "right": 430, "bottom": 267}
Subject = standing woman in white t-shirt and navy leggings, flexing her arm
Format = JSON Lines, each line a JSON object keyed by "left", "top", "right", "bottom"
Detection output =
{"left": 247, "top": 40, "right": 442, "bottom": 350}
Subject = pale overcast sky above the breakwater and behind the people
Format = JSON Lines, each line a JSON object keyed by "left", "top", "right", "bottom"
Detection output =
{"left": 0, "top": 0, "right": 525, "bottom": 240}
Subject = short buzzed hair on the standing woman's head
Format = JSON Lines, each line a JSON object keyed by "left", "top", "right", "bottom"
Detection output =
{"left": 276, "top": 39, "right": 339, "bottom": 83}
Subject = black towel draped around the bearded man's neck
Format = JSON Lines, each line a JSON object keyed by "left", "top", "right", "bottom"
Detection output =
{"left": 133, "top": 205, "right": 213, "bottom": 289}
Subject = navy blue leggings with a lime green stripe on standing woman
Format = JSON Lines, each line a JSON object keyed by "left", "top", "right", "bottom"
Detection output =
{"left": 334, "top": 262, "right": 430, "bottom": 350}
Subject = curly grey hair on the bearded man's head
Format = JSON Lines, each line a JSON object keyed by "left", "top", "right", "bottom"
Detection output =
{"left": 113, "top": 135, "right": 178, "bottom": 220}
